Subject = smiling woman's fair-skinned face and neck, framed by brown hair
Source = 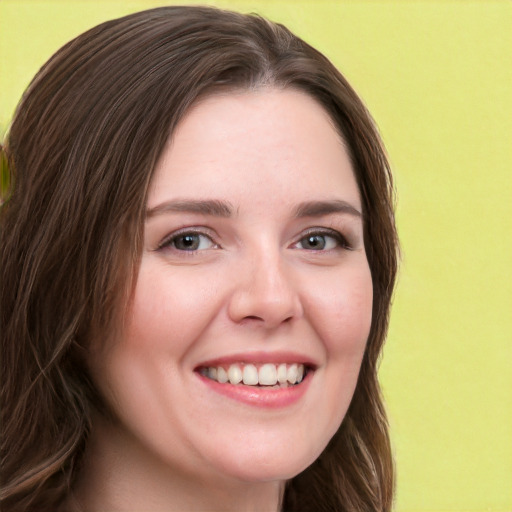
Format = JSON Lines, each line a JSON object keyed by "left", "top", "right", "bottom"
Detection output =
{"left": 76, "top": 89, "right": 372, "bottom": 512}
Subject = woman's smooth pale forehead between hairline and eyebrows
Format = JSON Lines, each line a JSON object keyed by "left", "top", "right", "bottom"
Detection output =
{"left": 148, "top": 88, "right": 360, "bottom": 209}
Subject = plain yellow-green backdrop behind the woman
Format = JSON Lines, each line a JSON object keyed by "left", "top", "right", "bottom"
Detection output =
{"left": 0, "top": 0, "right": 512, "bottom": 512}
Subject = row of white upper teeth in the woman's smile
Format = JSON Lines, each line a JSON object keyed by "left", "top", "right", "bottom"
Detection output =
{"left": 201, "top": 363, "right": 304, "bottom": 386}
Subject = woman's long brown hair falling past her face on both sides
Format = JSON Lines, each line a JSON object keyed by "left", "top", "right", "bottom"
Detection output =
{"left": 0, "top": 7, "right": 398, "bottom": 512}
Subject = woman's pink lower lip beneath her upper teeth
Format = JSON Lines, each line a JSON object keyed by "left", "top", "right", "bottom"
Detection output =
{"left": 197, "top": 371, "right": 314, "bottom": 409}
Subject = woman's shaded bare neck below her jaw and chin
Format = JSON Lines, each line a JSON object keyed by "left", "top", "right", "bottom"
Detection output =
{"left": 73, "top": 420, "right": 284, "bottom": 512}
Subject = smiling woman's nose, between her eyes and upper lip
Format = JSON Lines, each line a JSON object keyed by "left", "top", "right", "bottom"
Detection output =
{"left": 228, "top": 254, "right": 303, "bottom": 329}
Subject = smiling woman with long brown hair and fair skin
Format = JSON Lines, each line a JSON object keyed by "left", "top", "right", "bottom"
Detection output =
{"left": 0, "top": 7, "right": 397, "bottom": 511}
